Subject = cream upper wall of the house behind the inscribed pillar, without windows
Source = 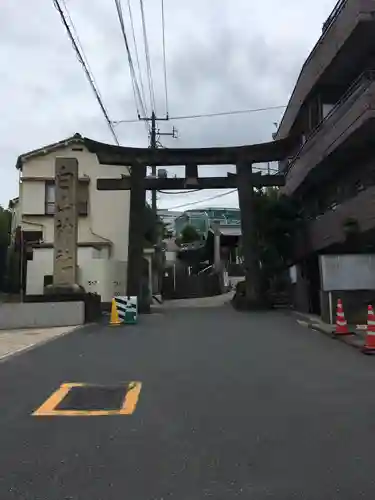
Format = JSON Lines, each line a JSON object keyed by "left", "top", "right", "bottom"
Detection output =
{"left": 20, "top": 145, "right": 130, "bottom": 262}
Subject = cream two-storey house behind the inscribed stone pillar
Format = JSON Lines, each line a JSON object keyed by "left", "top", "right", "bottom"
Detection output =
{"left": 13, "top": 134, "right": 153, "bottom": 302}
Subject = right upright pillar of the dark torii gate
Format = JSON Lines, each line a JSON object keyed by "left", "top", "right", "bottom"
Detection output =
{"left": 235, "top": 162, "right": 266, "bottom": 309}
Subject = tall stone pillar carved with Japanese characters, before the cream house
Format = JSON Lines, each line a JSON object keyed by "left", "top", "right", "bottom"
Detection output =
{"left": 53, "top": 158, "right": 78, "bottom": 286}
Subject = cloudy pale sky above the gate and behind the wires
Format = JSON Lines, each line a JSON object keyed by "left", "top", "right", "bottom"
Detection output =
{"left": 0, "top": 0, "right": 337, "bottom": 210}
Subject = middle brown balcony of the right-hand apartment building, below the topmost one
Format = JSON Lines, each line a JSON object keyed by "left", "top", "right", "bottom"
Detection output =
{"left": 283, "top": 70, "right": 375, "bottom": 195}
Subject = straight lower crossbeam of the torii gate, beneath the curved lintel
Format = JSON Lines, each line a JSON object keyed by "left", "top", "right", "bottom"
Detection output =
{"left": 96, "top": 173, "right": 285, "bottom": 191}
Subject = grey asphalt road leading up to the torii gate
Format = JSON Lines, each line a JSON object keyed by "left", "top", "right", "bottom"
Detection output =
{"left": 0, "top": 307, "right": 375, "bottom": 500}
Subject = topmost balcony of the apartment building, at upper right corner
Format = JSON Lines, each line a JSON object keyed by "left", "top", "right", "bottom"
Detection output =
{"left": 277, "top": 0, "right": 375, "bottom": 138}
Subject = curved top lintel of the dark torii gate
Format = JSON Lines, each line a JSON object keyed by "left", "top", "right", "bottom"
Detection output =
{"left": 84, "top": 137, "right": 297, "bottom": 166}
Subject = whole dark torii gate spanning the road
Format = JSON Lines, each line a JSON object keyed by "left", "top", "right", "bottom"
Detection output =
{"left": 84, "top": 137, "right": 296, "bottom": 309}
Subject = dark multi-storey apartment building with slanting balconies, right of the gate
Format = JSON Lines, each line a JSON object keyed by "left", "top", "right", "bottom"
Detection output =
{"left": 275, "top": 0, "right": 375, "bottom": 318}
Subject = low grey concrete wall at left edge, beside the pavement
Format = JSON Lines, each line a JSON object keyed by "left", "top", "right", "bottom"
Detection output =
{"left": 0, "top": 302, "right": 85, "bottom": 330}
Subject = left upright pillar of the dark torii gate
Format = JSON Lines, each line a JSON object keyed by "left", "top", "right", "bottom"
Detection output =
{"left": 127, "top": 164, "right": 150, "bottom": 312}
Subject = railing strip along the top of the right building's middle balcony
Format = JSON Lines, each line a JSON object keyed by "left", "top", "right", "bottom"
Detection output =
{"left": 285, "top": 70, "right": 375, "bottom": 174}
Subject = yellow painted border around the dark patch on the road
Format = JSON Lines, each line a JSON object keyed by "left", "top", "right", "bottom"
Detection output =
{"left": 32, "top": 382, "right": 142, "bottom": 417}
